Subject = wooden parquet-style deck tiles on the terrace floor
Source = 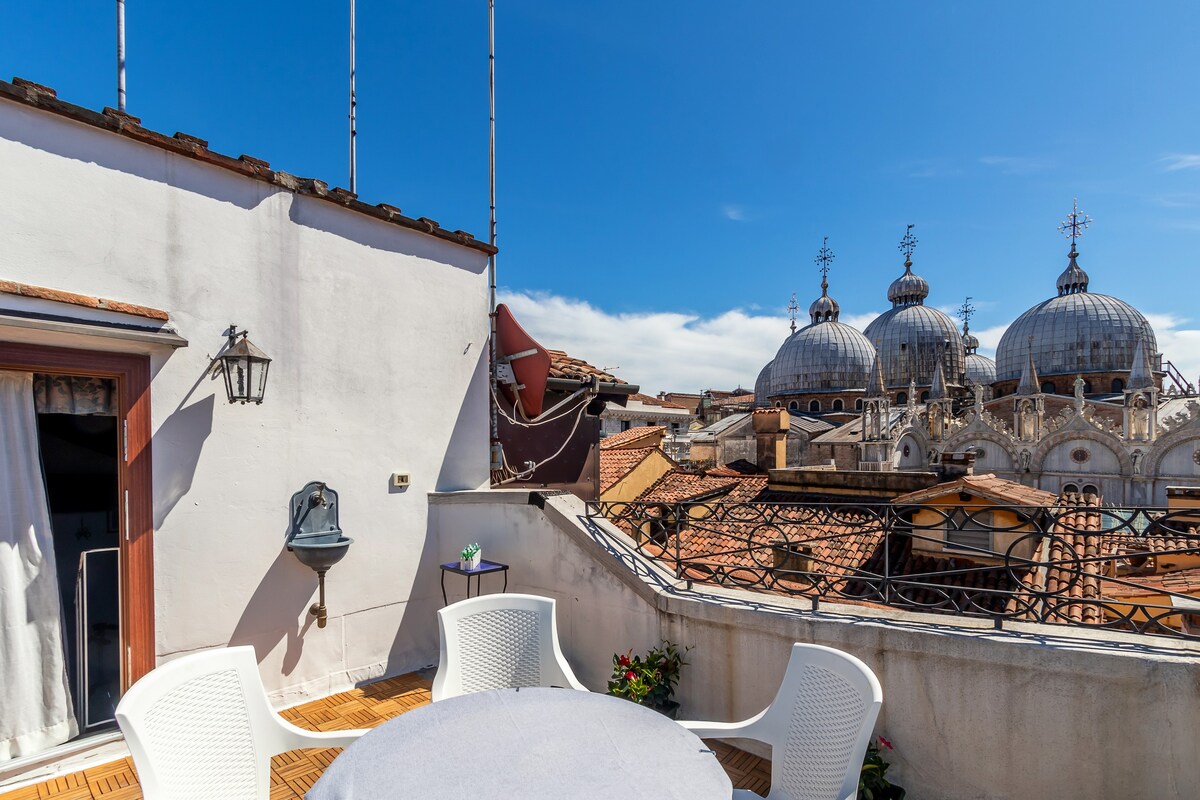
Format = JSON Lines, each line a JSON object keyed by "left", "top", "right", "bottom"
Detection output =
{"left": 0, "top": 673, "right": 770, "bottom": 800}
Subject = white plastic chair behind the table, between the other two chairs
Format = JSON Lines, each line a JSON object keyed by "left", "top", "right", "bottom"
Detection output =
{"left": 432, "top": 594, "right": 588, "bottom": 703}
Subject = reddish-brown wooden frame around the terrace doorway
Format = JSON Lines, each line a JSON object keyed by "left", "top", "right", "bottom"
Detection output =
{"left": 0, "top": 341, "right": 155, "bottom": 691}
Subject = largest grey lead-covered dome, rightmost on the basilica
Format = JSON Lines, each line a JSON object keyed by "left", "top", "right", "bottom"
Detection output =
{"left": 996, "top": 247, "right": 1158, "bottom": 380}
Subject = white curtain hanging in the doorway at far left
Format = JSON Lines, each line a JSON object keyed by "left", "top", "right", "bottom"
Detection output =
{"left": 0, "top": 371, "right": 78, "bottom": 762}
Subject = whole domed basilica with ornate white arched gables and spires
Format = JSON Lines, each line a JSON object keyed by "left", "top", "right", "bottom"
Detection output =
{"left": 755, "top": 210, "right": 1200, "bottom": 506}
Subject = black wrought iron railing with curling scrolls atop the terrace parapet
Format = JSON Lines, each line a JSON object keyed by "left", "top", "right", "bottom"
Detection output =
{"left": 588, "top": 499, "right": 1200, "bottom": 639}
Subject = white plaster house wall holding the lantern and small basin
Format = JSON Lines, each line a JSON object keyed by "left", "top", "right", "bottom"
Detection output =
{"left": 0, "top": 103, "right": 487, "bottom": 699}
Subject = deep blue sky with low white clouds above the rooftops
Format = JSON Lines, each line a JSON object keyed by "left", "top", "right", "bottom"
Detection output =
{"left": 0, "top": 0, "right": 1200, "bottom": 390}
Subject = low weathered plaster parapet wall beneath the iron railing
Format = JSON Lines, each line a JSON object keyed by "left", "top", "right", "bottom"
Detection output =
{"left": 432, "top": 493, "right": 1200, "bottom": 800}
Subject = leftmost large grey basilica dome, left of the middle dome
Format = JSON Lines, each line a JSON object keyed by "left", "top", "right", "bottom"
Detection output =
{"left": 756, "top": 281, "right": 875, "bottom": 397}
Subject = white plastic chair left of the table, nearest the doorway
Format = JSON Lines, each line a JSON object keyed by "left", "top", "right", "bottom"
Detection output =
{"left": 116, "top": 646, "right": 366, "bottom": 800}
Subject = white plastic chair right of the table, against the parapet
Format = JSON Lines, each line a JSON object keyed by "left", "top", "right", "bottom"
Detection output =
{"left": 679, "top": 644, "right": 883, "bottom": 800}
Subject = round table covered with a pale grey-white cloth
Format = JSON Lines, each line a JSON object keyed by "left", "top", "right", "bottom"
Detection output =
{"left": 305, "top": 688, "right": 733, "bottom": 800}
